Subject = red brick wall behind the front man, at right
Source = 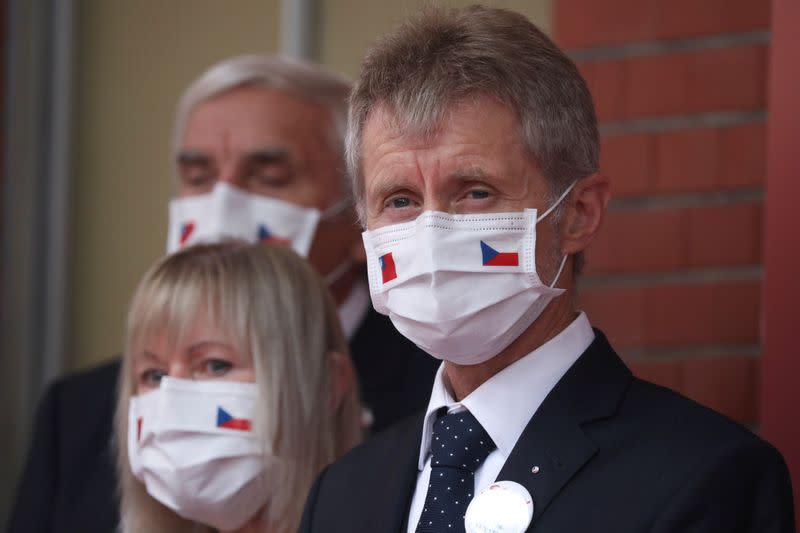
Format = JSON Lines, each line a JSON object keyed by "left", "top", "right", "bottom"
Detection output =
{"left": 554, "top": 0, "right": 770, "bottom": 425}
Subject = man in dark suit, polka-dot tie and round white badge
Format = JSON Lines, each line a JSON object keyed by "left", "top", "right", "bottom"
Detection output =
{"left": 300, "top": 7, "right": 794, "bottom": 533}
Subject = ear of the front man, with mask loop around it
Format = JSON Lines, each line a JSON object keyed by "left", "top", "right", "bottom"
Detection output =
{"left": 561, "top": 173, "right": 611, "bottom": 254}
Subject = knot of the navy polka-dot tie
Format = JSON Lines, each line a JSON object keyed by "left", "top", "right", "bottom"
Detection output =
{"left": 431, "top": 411, "right": 496, "bottom": 472}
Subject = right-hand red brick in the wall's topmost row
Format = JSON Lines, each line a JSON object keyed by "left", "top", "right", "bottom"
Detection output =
{"left": 653, "top": 0, "right": 770, "bottom": 39}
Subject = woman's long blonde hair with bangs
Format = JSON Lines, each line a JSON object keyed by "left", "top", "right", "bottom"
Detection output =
{"left": 115, "top": 241, "right": 361, "bottom": 533}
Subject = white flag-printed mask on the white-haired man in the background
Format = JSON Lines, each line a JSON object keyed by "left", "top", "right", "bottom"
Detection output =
{"left": 167, "top": 182, "right": 349, "bottom": 257}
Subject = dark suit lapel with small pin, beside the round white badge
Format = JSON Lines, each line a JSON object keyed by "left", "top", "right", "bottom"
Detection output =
{"left": 497, "top": 330, "right": 631, "bottom": 531}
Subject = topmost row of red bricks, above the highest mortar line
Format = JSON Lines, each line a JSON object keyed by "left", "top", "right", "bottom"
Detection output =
{"left": 554, "top": 0, "right": 770, "bottom": 48}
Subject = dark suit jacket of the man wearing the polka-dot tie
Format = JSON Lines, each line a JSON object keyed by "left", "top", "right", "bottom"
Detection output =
{"left": 300, "top": 332, "right": 794, "bottom": 533}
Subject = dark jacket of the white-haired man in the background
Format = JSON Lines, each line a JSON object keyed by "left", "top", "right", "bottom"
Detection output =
{"left": 8, "top": 308, "right": 438, "bottom": 533}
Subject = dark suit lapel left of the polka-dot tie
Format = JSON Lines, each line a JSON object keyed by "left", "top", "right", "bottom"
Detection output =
{"left": 364, "top": 416, "right": 424, "bottom": 533}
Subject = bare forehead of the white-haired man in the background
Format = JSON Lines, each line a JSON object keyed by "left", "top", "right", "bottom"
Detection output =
{"left": 180, "top": 86, "right": 332, "bottom": 152}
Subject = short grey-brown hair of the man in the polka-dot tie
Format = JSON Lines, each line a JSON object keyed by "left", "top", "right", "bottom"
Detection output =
{"left": 346, "top": 6, "right": 600, "bottom": 222}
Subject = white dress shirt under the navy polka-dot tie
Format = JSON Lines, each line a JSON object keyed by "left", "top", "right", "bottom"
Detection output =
{"left": 407, "top": 312, "right": 594, "bottom": 533}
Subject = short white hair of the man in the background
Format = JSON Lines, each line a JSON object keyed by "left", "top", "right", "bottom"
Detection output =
{"left": 173, "top": 55, "right": 351, "bottom": 169}
